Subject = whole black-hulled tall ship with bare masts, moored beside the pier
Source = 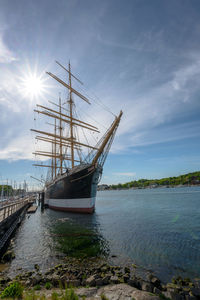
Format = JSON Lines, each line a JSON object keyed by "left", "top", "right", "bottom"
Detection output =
{"left": 31, "top": 61, "right": 122, "bottom": 213}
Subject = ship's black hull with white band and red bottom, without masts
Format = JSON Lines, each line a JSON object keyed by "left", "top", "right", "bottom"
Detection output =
{"left": 45, "top": 164, "right": 101, "bottom": 213}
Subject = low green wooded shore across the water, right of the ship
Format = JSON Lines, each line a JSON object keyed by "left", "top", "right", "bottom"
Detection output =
{"left": 98, "top": 171, "right": 200, "bottom": 191}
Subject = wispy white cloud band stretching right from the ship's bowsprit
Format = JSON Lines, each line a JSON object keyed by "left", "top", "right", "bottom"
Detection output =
{"left": 108, "top": 56, "right": 200, "bottom": 152}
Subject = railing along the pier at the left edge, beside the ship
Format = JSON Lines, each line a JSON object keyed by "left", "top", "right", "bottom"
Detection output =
{"left": 0, "top": 198, "right": 30, "bottom": 223}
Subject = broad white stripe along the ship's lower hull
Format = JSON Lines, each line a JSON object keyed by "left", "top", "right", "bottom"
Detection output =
{"left": 45, "top": 197, "right": 96, "bottom": 209}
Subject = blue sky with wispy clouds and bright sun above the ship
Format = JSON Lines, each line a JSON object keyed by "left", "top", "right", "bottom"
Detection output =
{"left": 0, "top": 0, "right": 200, "bottom": 186}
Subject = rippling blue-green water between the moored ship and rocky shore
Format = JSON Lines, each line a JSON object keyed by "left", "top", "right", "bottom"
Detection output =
{"left": 6, "top": 187, "right": 200, "bottom": 281}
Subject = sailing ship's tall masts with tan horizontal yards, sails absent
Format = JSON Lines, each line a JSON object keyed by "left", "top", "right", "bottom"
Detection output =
{"left": 31, "top": 61, "right": 99, "bottom": 179}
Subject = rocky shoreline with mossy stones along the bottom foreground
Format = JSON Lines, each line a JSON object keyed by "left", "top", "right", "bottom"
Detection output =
{"left": 0, "top": 258, "right": 200, "bottom": 300}
